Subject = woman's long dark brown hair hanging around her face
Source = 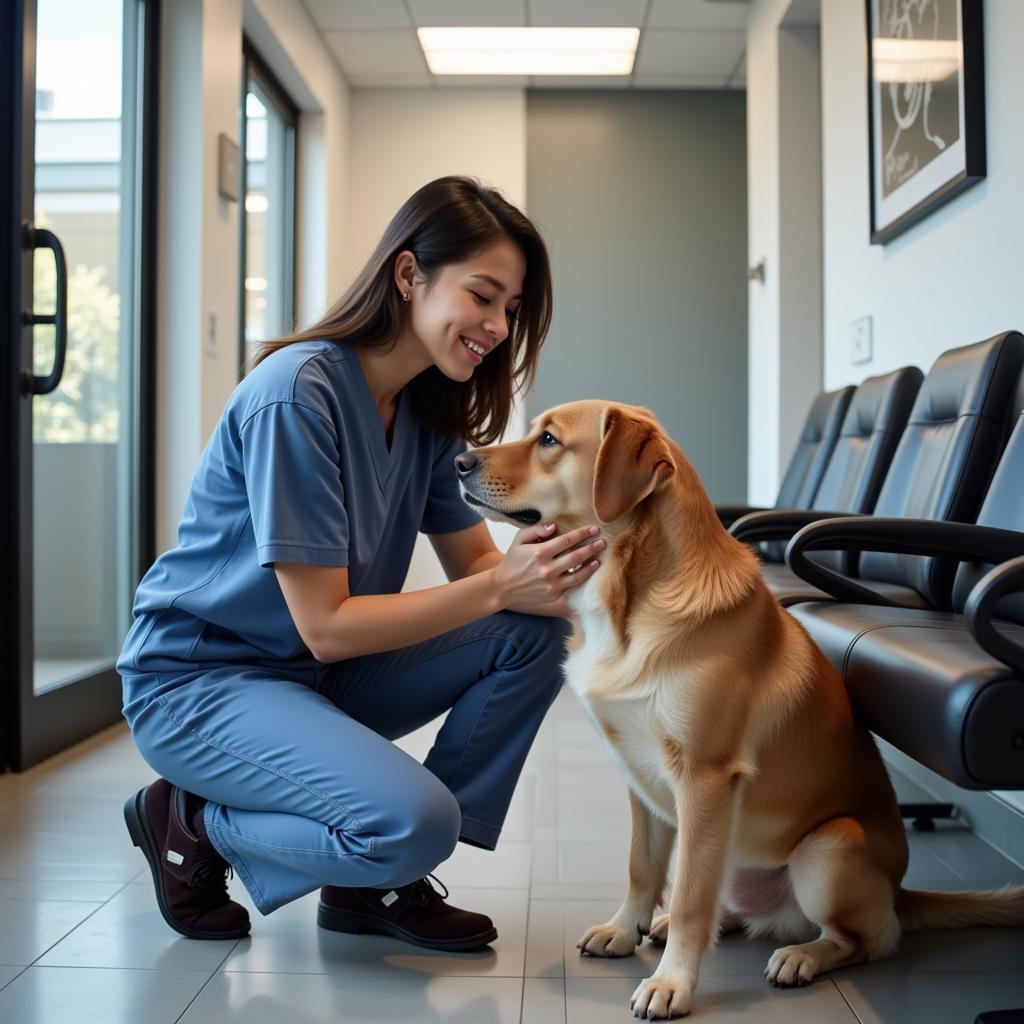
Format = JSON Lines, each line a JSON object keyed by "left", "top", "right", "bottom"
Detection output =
{"left": 252, "top": 176, "right": 551, "bottom": 445}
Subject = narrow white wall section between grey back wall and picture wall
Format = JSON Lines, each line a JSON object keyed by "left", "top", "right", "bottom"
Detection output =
{"left": 746, "top": 0, "right": 821, "bottom": 505}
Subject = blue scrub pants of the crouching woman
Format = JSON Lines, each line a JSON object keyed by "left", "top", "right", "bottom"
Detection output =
{"left": 123, "top": 611, "right": 568, "bottom": 914}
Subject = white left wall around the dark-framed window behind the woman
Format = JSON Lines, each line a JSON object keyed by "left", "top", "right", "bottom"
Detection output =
{"left": 157, "top": 0, "right": 348, "bottom": 553}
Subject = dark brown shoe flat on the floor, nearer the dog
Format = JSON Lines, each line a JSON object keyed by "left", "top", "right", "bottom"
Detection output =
{"left": 316, "top": 874, "right": 498, "bottom": 952}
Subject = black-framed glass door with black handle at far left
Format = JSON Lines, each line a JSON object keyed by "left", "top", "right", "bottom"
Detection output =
{"left": 0, "top": 0, "right": 156, "bottom": 770}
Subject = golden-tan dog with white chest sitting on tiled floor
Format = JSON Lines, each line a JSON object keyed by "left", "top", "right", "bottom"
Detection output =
{"left": 460, "top": 400, "right": 1024, "bottom": 1020}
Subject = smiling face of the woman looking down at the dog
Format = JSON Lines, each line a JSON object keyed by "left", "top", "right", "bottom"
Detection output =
{"left": 395, "top": 239, "right": 526, "bottom": 381}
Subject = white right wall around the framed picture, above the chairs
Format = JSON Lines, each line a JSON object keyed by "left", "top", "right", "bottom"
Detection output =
{"left": 821, "top": 0, "right": 1024, "bottom": 387}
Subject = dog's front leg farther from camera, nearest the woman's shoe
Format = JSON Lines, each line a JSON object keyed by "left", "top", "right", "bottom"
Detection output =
{"left": 577, "top": 790, "right": 676, "bottom": 956}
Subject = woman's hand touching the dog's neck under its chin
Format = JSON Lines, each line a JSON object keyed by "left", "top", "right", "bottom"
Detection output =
{"left": 490, "top": 523, "right": 605, "bottom": 608}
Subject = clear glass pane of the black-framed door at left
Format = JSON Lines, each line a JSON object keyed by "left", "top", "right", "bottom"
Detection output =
{"left": 32, "top": 0, "right": 153, "bottom": 692}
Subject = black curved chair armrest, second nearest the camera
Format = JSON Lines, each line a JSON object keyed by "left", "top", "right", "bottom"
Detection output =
{"left": 785, "top": 516, "right": 1024, "bottom": 607}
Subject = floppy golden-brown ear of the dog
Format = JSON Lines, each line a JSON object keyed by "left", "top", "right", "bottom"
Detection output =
{"left": 594, "top": 406, "right": 676, "bottom": 522}
